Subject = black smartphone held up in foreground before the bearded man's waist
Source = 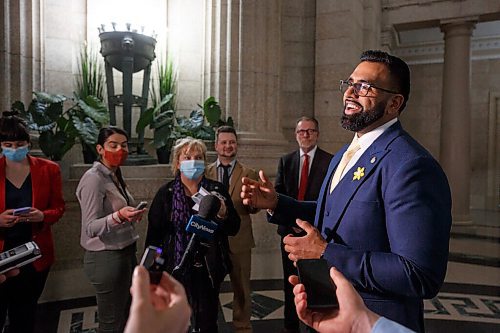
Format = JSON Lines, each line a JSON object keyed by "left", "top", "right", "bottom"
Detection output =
{"left": 297, "top": 259, "right": 339, "bottom": 309}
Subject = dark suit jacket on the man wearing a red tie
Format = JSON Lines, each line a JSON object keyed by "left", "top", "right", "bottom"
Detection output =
{"left": 274, "top": 147, "right": 332, "bottom": 236}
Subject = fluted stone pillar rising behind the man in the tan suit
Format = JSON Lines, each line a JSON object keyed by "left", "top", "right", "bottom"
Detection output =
{"left": 203, "top": 0, "right": 287, "bottom": 175}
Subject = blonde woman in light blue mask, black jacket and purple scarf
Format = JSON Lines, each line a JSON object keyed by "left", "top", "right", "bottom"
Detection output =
{"left": 146, "top": 138, "right": 240, "bottom": 332}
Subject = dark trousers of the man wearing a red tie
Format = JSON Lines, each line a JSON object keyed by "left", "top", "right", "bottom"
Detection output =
{"left": 281, "top": 237, "right": 299, "bottom": 332}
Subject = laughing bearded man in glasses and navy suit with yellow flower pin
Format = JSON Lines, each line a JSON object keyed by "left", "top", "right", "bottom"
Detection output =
{"left": 241, "top": 51, "right": 451, "bottom": 332}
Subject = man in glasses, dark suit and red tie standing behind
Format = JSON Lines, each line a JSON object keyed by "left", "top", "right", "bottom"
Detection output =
{"left": 275, "top": 117, "right": 332, "bottom": 333}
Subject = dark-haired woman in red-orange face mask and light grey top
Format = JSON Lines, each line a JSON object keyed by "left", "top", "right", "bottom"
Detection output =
{"left": 76, "top": 127, "right": 145, "bottom": 332}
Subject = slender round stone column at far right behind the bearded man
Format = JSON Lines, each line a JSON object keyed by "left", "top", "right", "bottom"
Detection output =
{"left": 440, "top": 18, "right": 477, "bottom": 226}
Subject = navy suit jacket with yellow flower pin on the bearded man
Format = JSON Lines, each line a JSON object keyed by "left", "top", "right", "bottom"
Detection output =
{"left": 270, "top": 122, "right": 451, "bottom": 332}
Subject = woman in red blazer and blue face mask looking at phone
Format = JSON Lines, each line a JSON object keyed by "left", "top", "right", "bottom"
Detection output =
{"left": 0, "top": 112, "right": 64, "bottom": 332}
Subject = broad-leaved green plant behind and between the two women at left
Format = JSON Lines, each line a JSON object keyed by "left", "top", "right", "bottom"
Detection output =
{"left": 12, "top": 92, "right": 109, "bottom": 161}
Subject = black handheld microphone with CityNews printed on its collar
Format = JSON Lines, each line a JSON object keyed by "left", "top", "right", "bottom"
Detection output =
{"left": 172, "top": 194, "right": 220, "bottom": 277}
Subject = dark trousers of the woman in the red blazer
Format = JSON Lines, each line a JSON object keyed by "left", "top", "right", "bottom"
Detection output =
{"left": 0, "top": 265, "right": 49, "bottom": 333}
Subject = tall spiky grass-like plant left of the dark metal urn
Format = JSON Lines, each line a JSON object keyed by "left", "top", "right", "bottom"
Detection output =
{"left": 75, "top": 43, "right": 109, "bottom": 164}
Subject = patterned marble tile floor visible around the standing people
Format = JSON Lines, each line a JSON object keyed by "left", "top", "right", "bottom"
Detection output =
{"left": 36, "top": 212, "right": 500, "bottom": 333}
